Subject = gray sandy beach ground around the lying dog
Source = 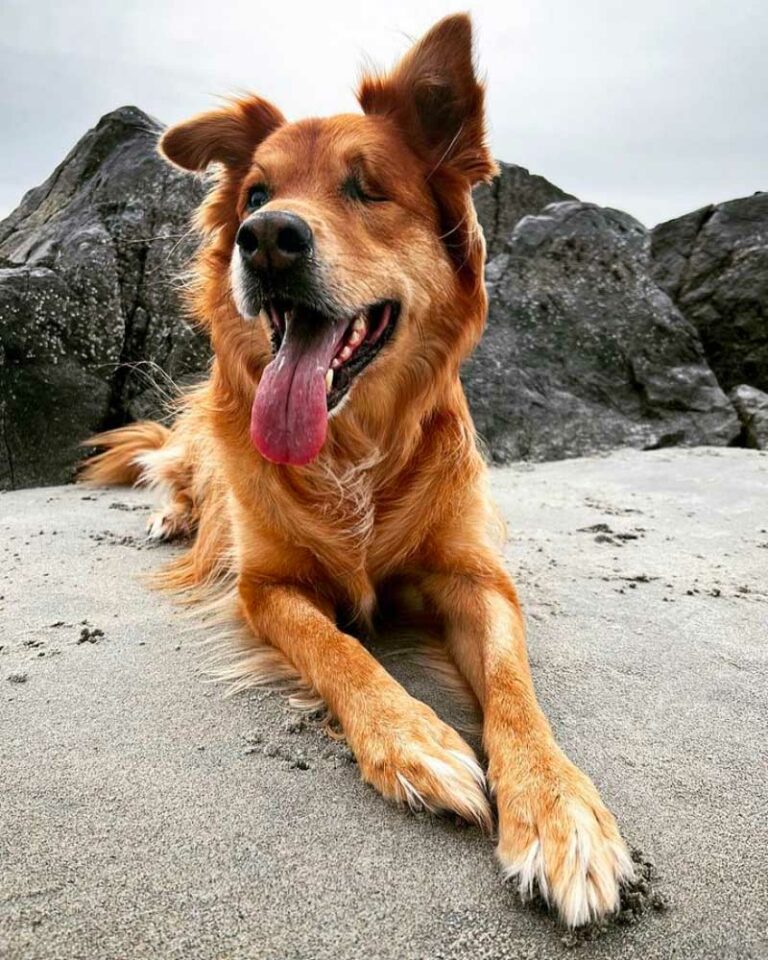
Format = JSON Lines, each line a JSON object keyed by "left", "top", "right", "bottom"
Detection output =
{"left": 0, "top": 450, "right": 768, "bottom": 960}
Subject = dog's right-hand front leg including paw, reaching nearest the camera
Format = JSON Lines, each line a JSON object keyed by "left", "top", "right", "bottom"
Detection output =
{"left": 424, "top": 570, "right": 633, "bottom": 926}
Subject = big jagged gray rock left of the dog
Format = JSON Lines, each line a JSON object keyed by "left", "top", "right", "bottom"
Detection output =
{"left": 0, "top": 107, "right": 208, "bottom": 489}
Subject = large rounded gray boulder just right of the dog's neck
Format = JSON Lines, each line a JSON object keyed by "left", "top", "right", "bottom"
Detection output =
{"left": 463, "top": 201, "right": 739, "bottom": 462}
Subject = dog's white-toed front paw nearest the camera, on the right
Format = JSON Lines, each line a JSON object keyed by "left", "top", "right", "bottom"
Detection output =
{"left": 495, "top": 760, "right": 634, "bottom": 927}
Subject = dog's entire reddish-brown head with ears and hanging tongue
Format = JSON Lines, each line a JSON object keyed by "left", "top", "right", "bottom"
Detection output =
{"left": 160, "top": 16, "right": 495, "bottom": 465}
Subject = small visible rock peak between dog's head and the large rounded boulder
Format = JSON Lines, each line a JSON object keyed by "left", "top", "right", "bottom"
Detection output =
{"left": 473, "top": 161, "right": 576, "bottom": 260}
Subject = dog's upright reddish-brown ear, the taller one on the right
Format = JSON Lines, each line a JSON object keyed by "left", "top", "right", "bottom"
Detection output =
{"left": 357, "top": 14, "right": 496, "bottom": 184}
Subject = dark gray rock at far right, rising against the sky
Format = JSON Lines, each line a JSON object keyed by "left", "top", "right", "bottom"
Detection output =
{"left": 651, "top": 193, "right": 768, "bottom": 390}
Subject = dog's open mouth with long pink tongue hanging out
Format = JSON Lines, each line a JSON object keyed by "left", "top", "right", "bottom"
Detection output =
{"left": 251, "top": 300, "right": 400, "bottom": 466}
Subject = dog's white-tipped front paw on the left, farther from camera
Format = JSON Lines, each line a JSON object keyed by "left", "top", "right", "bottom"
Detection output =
{"left": 347, "top": 694, "right": 491, "bottom": 830}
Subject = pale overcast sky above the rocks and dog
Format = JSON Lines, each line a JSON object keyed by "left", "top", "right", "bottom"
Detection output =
{"left": 0, "top": 0, "right": 768, "bottom": 226}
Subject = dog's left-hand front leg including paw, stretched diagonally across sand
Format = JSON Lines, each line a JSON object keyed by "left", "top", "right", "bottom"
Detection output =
{"left": 239, "top": 578, "right": 490, "bottom": 827}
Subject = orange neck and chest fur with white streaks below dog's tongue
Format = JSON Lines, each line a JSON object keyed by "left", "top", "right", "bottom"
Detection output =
{"left": 198, "top": 288, "right": 485, "bottom": 600}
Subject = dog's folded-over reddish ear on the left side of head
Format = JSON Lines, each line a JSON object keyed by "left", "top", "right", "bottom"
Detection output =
{"left": 159, "top": 97, "right": 285, "bottom": 170}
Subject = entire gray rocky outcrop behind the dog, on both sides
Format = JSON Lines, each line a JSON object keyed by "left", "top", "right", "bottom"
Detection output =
{"left": 0, "top": 107, "right": 756, "bottom": 489}
